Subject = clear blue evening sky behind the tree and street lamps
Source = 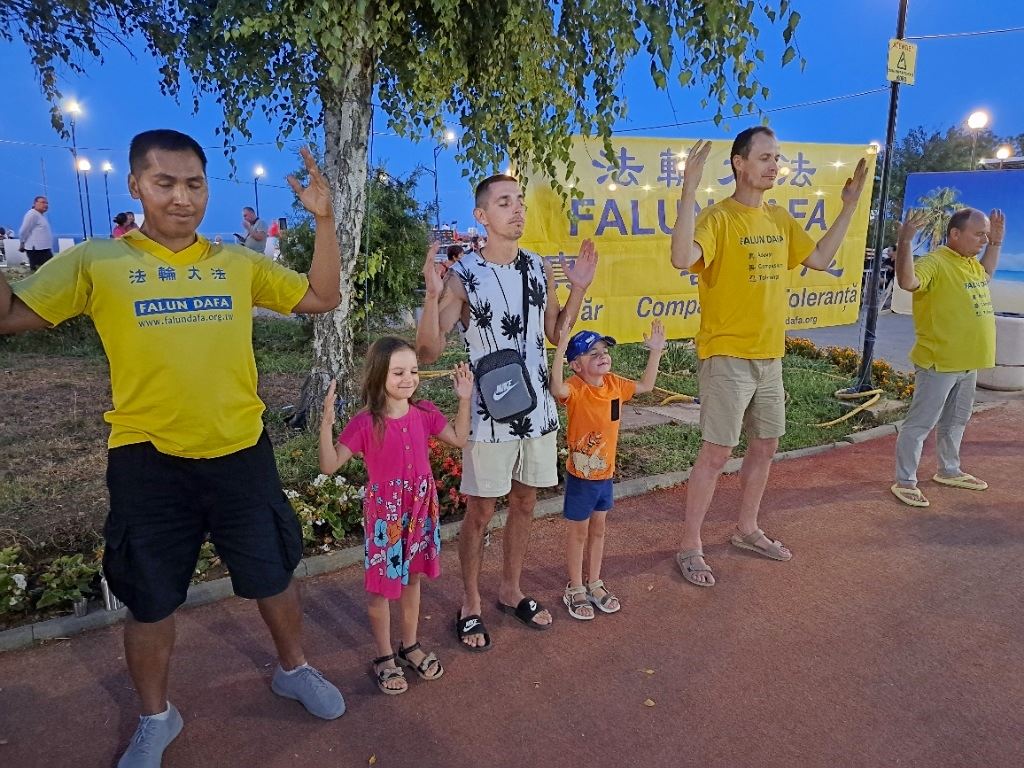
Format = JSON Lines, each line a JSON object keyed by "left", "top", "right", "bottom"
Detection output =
{"left": 0, "top": 0, "right": 1024, "bottom": 237}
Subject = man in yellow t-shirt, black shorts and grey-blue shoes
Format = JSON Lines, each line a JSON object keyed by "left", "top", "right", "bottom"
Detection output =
{"left": 0, "top": 130, "right": 344, "bottom": 768}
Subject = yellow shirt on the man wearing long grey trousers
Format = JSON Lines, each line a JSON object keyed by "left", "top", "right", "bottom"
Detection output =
{"left": 910, "top": 241, "right": 995, "bottom": 373}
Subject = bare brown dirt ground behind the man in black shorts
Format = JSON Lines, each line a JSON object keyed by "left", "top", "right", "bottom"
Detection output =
{"left": 0, "top": 354, "right": 302, "bottom": 556}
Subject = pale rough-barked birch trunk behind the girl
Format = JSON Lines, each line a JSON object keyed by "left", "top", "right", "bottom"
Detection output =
{"left": 290, "top": 52, "right": 374, "bottom": 428}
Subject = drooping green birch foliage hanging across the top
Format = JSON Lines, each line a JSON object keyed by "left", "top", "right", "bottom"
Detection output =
{"left": 14, "top": 0, "right": 800, "bottom": 191}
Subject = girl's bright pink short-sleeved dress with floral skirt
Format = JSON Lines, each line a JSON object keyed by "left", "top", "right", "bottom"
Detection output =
{"left": 338, "top": 400, "right": 447, "bottom": 600}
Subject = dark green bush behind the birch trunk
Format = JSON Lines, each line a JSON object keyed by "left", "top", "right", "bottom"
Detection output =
{"left": 281, "top": 168, "right": 427, "bottom": 328}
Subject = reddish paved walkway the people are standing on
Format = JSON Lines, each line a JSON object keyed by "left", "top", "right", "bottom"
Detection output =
{"left": 0, "top": 402, "right": 1024, "bottom": 768}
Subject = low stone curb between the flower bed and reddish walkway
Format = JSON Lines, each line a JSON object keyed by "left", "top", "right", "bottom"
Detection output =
{"left": 0, "top": 421, "right": 917, "bottom": 653}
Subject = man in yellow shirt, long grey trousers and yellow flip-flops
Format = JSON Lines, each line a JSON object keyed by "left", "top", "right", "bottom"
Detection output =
{"left": 891, "top": 208, "right": 1007, "bottom": 507}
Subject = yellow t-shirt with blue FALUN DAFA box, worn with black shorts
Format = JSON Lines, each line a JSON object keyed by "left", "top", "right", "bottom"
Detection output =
{"left": 11, "top": 229, "right": 309, "bottom": 459}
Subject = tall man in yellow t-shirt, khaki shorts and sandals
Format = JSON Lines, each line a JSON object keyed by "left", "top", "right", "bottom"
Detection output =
{"left": 672, "top": 126, "right": 867, "bottom": 587}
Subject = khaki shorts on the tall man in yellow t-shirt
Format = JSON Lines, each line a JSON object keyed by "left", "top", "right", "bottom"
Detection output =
{"left": 697, "top": 354, "right": 785, "bottom": 447}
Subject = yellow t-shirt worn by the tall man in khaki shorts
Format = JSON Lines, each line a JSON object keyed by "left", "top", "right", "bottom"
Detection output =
{"left": 690, "top": 198, "right": 815, "bottom": 359}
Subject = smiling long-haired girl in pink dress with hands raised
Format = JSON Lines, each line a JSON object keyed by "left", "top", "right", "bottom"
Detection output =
{"left": 319, "top": 336, "right": 473, "bottom": 695}
